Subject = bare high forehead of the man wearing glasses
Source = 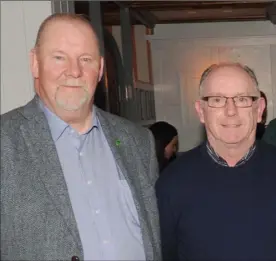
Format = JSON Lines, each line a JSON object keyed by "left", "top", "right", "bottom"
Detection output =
{"left": 204, "top": 67, "right": 256, "bottom": 96}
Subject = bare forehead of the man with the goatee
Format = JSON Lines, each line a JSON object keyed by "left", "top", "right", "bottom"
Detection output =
{"left": 38, "top": 20, "right": 99, "bottom": 51}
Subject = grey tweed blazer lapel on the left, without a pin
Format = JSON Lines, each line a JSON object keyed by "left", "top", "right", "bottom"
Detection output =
{"left": 18, "top": 97, "right": 83, "bottom": 255}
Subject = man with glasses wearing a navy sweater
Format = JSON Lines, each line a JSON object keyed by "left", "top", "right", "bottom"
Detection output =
{"left": 156, "top": 63, "right": 276, "bottom": 261}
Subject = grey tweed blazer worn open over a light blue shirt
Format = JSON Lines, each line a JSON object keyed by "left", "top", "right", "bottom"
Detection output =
{"left": 1, "top": 97, "right": 161, "bottom": 260}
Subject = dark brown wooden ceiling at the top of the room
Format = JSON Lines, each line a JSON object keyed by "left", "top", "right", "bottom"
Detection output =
{"left": 75, "top": 0, "right": 276, "bottom": 27}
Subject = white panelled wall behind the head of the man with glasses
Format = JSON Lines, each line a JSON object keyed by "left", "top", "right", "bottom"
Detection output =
{"left": 148, "top": 21, "right": 276, "bottom": 151}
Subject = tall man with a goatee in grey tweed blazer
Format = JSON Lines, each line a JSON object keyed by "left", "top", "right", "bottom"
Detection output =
{"left": 1, "top": 14, "right": 161, "bottom": 260}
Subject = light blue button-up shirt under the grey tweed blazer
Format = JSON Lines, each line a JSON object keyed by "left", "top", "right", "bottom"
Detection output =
{"left": 40, "top": 102, "right": 145, "bottom": 260}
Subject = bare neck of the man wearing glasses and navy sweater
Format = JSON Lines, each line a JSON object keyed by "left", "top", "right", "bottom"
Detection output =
{"left": 208, "top": 140, "right": 255, "bottom": 167}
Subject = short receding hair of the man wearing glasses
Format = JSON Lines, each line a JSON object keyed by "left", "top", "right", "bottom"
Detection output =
{"left": 199, "top": 63, "right": 260, "bottom": 97}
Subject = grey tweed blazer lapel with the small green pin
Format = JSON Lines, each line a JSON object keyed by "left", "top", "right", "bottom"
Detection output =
{"left": 96, "top": 108, "right": 154, "bottom": 260}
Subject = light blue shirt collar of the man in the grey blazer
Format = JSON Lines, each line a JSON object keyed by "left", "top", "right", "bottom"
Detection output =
{"left": 39, "top": 99, "right": 99, "bottom": 142}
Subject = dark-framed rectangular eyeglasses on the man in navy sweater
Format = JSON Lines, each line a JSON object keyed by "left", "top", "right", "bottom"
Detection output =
{"left": 201, "top": 96, "right": 259, "bottom": 108}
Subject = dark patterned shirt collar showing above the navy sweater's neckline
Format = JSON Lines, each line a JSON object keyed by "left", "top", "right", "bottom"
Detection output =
{"left": 206, "top": 142, "right": 256, "bottom": 167}
